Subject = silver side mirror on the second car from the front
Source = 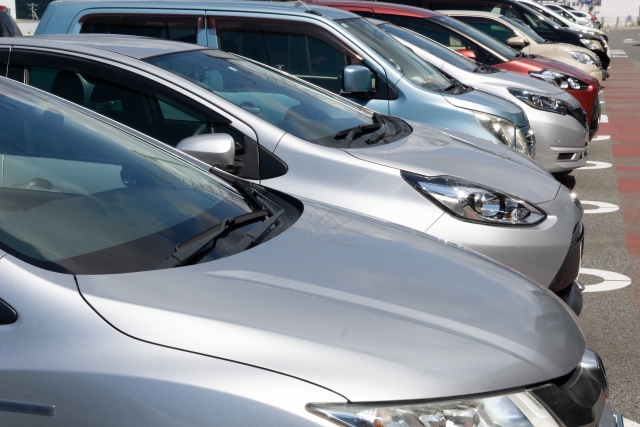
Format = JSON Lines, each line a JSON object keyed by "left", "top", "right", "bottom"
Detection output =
{"left": 176, "top": 133, "right": 236, "bottom": 166}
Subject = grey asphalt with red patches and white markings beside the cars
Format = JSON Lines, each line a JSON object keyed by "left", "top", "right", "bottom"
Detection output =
{"left": 563, "top": 29, "right": 640, "bottom": 427}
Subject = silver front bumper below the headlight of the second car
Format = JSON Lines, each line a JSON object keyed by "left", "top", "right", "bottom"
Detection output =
{"left": 426, "top": 186, "right": 582, "bottom": 288}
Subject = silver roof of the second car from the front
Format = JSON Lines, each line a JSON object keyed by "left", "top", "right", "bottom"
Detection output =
{"left": 0, "top": 34, "right": 210, "bottom": 59}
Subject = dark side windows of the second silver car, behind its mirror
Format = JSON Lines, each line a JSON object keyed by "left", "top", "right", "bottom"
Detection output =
{"left": 8, "top": 49, "right": 286, "bottom": 180}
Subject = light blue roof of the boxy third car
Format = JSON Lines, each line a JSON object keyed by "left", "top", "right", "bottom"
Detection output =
{"left": 52, "top": 0, "right": 354, "bottom": 19}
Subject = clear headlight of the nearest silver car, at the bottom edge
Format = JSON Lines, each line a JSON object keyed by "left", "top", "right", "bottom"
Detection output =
{"left": 307, "top": 391, "right": 558, "bottom": 427}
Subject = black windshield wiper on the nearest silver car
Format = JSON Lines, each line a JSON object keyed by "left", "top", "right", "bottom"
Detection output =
{"left": 158, "top": 209, "right": 272, "bottom": 270}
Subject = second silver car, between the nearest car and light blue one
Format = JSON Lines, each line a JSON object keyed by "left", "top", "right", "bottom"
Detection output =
{"left": 0, "top": 35, "right": 584, "bottom": 312}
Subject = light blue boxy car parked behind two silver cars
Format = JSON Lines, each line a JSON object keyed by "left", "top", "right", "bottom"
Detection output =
{"left": 33, "top": 0, "right": 534, "bottom": 156}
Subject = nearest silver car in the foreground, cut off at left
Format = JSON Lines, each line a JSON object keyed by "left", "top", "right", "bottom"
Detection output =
{"left": 0, "top": 78, "right": 621, "bottom": 427}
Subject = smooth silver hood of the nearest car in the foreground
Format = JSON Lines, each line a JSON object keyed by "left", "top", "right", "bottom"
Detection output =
{"left": 77, "top": 202, "right": 585, "bottom": 401}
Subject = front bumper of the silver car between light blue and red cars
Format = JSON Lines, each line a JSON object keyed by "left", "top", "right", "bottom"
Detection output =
{"left": 526, "top": 109, "right": 588, "bottom": 173}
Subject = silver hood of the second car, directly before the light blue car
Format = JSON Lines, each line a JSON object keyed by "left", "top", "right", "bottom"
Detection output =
{"left": 345, "top": 122, "right": 560, "bottom": 203}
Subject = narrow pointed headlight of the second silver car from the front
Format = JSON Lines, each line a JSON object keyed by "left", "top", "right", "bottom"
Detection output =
{"left": 401, "top": 171, "right": 547, "bottom": 226}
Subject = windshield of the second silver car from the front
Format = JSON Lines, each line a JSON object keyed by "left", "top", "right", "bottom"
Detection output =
{"left": 146, "top": 49, "right": 373, "bottom": 145}
